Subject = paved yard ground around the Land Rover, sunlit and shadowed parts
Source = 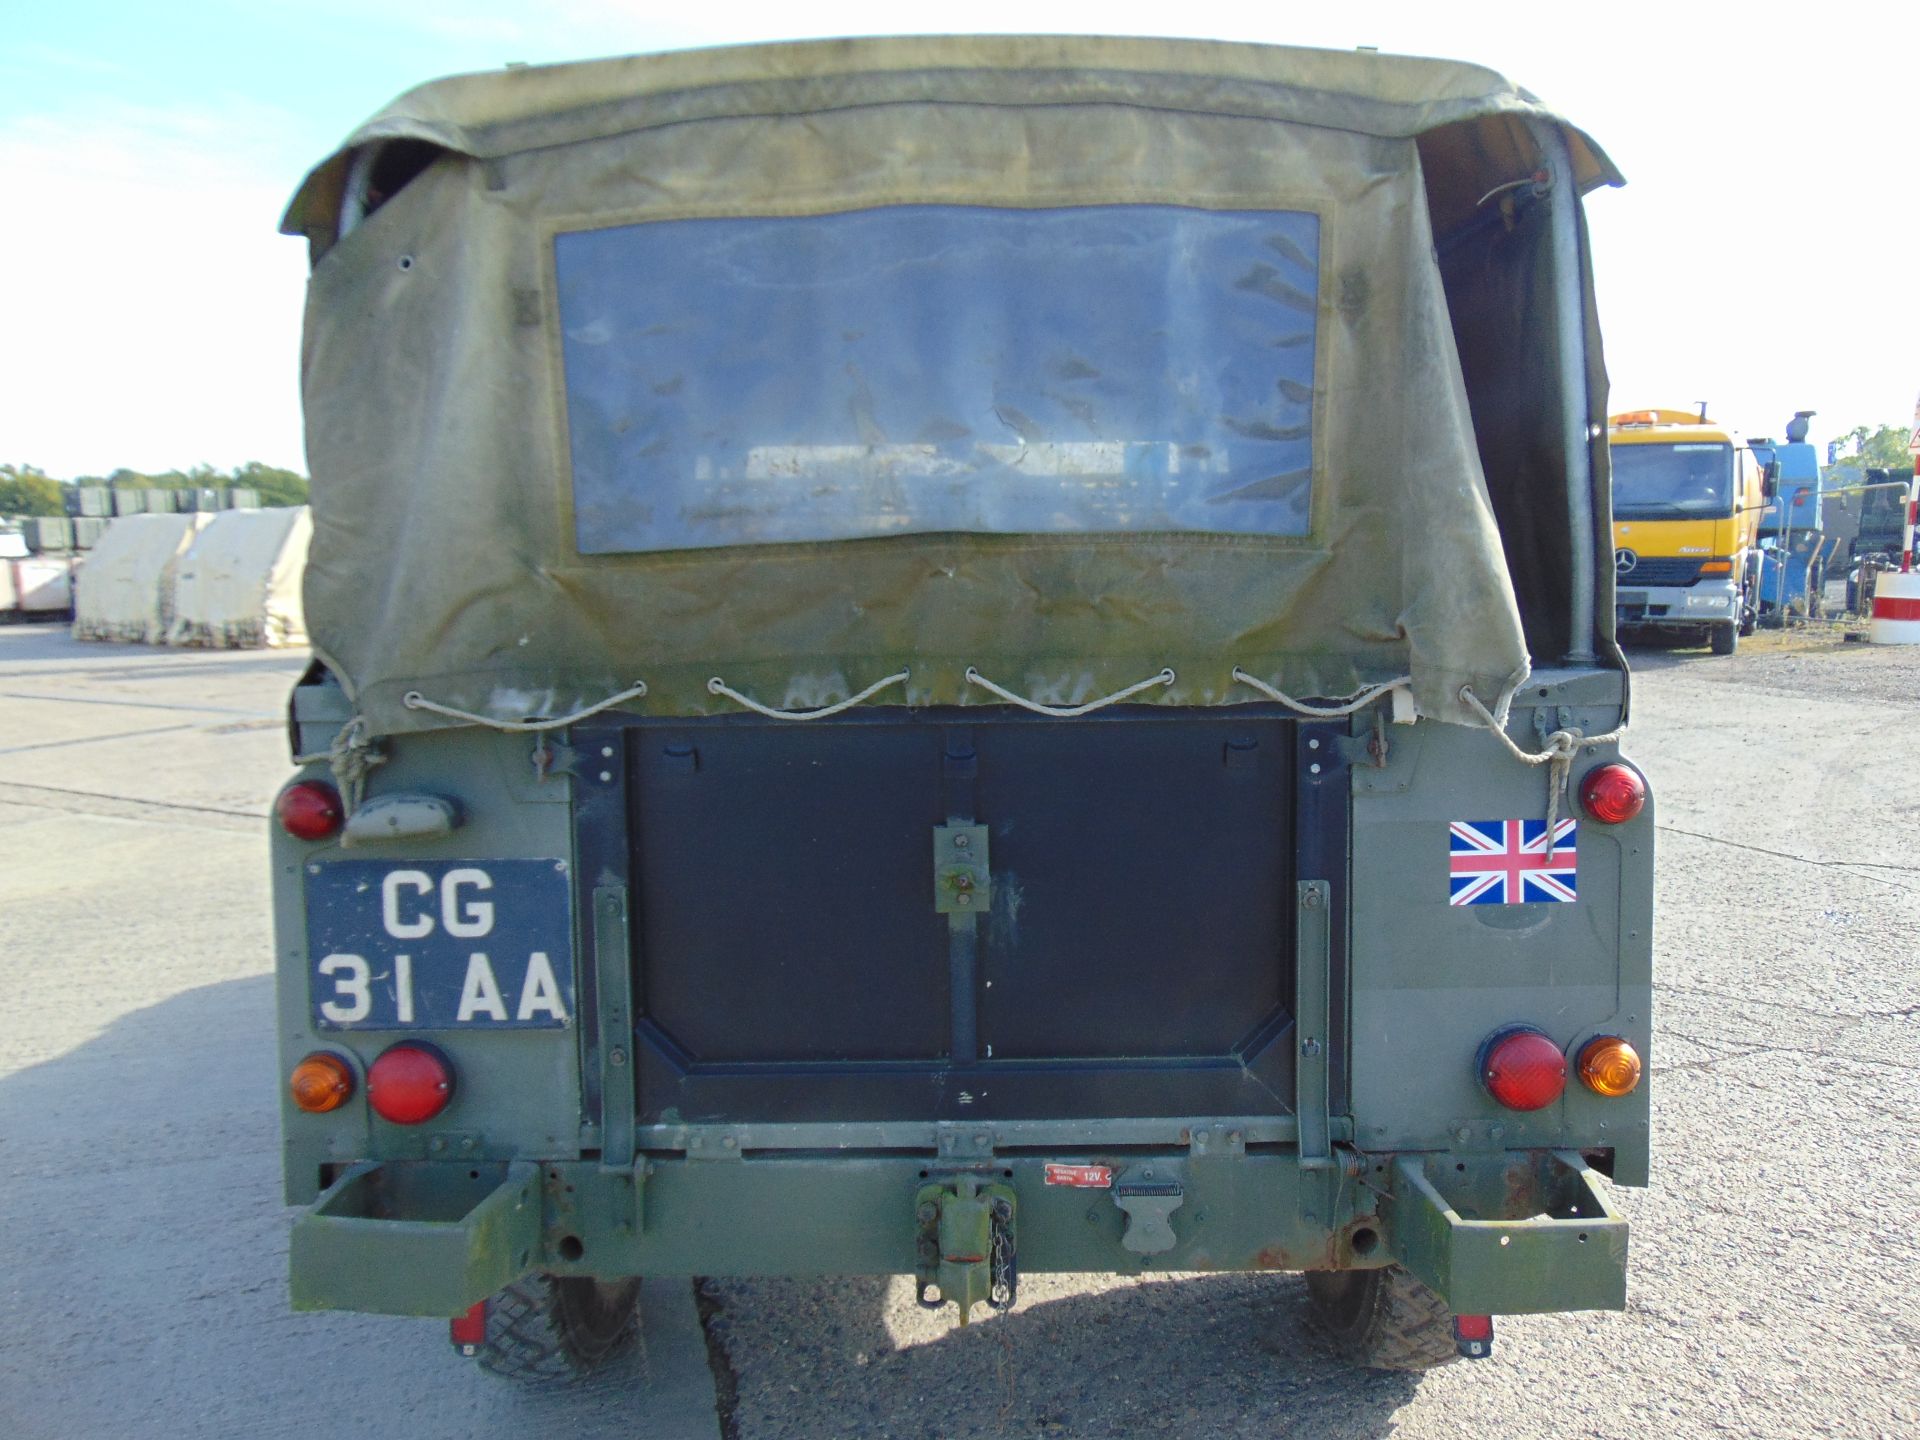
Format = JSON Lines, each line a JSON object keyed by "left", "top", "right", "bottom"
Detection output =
{"left": 0, "top": 628, "right": 1920, "bottom": 1440}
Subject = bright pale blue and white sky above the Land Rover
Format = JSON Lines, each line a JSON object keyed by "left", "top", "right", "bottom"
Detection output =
{"left": 0, "top": 0, "right": 1920, "bottom": 476}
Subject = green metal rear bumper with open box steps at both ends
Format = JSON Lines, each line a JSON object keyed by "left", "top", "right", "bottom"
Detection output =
{"left": 290, "top": 1131, "right": 1626, "bottom": 1315}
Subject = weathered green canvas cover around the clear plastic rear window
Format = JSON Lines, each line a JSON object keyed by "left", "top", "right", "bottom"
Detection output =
{"left": 284, "top": 38, "right": 1619, "bottom": 733}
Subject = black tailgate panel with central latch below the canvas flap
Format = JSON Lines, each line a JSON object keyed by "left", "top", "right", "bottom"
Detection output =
{"left": 576, "top": 707, "right": 1346, "bottom": 1125}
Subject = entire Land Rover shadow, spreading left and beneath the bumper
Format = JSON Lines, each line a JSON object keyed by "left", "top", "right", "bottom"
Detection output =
{"left": 0, "top": 983, "right": 1417, "bottom": 1440}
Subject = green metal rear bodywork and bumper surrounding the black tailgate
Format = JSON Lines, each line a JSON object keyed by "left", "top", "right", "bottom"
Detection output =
{"left": 273, "top": 672, "right": 1653, "bottom": 1315}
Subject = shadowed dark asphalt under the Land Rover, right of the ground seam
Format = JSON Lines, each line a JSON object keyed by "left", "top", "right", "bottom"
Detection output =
{"left": 703, "top": 1275, "right": 1419, "bottom": 1440}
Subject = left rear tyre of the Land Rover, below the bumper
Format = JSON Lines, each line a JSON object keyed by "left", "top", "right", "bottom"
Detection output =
{"left": 476, "top": 1275, "right": 639, "bottom": 1384}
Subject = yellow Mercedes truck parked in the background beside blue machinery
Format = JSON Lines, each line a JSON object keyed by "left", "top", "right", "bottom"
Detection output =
{"left": 1607, "top": 405, "right": 1768, "bottom": 655}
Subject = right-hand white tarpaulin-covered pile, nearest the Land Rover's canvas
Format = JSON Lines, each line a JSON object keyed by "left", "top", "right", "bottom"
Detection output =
{"left": 167, "top": 505, "right": 313, "bottom": 649}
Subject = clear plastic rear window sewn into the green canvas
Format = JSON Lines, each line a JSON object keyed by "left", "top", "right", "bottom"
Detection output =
{"left": 553, "top": 205, "right": 1319, "bottom": 553}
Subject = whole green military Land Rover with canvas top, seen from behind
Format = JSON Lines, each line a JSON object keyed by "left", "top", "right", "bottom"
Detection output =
{"left": 273, "top": 38, "right": 1653, "bottom": 1379}
